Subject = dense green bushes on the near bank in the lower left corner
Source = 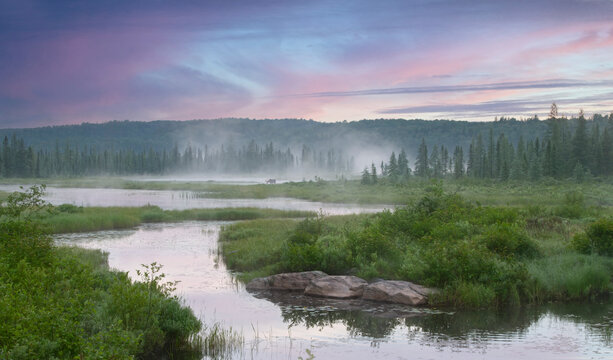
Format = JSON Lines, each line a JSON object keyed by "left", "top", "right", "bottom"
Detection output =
{"left": 0, "top": 187, "right": 203, "bottom": 359}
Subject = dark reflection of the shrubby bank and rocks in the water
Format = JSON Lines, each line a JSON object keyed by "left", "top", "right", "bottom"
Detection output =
{"left": 253, "top": 291, "right": 613, "bottom": 346}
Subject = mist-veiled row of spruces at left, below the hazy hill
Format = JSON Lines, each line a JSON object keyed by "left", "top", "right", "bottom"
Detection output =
{"left": 0, "top": 135, "right": 353, "bottom": 177}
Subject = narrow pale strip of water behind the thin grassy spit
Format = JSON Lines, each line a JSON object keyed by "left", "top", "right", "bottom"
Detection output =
{"left": 0, "top": 185, "right": 391, "bottom": 215}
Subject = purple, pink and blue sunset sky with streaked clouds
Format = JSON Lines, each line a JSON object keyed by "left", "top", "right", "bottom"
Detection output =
{"left": 0, "top": 0, "right": 613, "bottom": 128}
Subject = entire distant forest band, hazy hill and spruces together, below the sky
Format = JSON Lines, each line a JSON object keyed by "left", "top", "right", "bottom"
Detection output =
{"left": 0, "top": 106, "right": 613, "bottom": 179}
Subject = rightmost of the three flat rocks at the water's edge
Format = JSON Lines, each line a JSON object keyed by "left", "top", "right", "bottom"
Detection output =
{"left": 362, "top": 280, "right": 436, "bottom": 305}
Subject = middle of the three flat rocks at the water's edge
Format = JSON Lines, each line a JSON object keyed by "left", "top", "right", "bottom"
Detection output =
{"left": 304, "top": 276, "right": 368, "bottom": 299}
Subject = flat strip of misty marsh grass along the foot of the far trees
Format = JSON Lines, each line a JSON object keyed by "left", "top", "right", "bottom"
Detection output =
{"left": 0, "top": 177, "right": 613, "bottom": 210}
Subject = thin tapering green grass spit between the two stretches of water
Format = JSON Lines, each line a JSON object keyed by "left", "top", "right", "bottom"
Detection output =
{"left": 41, "top": 204, "right": 315, "bottom": 234}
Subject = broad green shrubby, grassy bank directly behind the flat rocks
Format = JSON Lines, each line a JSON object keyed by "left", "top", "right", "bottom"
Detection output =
{"left": 220, "top": 186, "right": 613, "bottom": 308}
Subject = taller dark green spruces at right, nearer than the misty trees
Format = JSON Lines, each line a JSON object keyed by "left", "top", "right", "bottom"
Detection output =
{"left": 376, "top": 104, "right": 613, "bottom": 183}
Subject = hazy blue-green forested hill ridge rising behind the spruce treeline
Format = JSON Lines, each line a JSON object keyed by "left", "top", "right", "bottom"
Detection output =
{"left": 0, "top": 118, "right": 547, "bottom": 158}
